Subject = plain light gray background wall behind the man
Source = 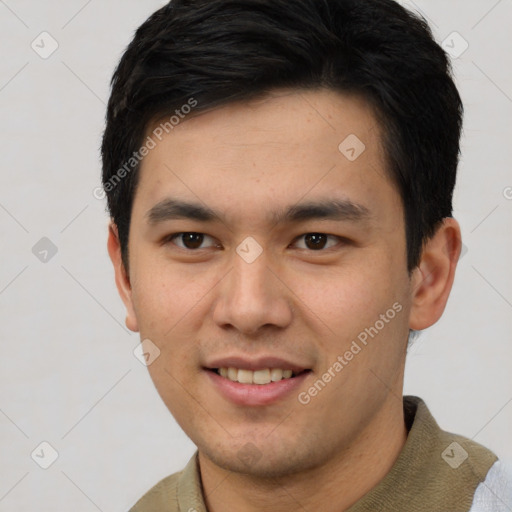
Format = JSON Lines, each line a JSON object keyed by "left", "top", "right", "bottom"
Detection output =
{"left": 0, "top": 0, "right": 512, "bottom": 512}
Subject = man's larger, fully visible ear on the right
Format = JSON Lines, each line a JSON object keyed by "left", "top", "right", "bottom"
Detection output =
{"left": 409, "top": 217, "right": 462, "bottom": 330}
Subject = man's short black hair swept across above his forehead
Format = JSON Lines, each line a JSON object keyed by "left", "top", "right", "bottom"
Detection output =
{"left": 101, "top": 0, "right": 463, "bottom": 272}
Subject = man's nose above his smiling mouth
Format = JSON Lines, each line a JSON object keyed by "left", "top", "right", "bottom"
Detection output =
{"left": 213, "top": 248, "right": 293, "bottom": 335}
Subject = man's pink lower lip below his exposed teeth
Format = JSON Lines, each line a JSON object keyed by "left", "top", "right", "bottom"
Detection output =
{"left": 205, "top": 370, "right": 311, "bottom": 405}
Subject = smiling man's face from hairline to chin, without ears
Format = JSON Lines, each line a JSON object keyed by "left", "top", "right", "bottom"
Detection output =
{"left": 121, "top": 91, "right": 411, "bottom": 476}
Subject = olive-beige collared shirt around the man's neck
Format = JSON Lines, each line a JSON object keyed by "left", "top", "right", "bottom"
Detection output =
{"left": 130, "top": 396, "right": 497, "bottom": 512}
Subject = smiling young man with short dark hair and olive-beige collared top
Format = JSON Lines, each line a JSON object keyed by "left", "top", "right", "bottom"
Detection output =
{"left": 102, "top": 0, "right": 506, "bottom": 512}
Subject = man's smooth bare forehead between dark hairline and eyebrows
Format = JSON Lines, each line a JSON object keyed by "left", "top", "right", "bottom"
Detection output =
{"left": 134, "top": 90, "right": 397, "bottom": 228}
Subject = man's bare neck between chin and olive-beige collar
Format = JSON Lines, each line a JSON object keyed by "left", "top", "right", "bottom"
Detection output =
{"left": 199, "top": 393, "right": 407, "bottom": 512}
